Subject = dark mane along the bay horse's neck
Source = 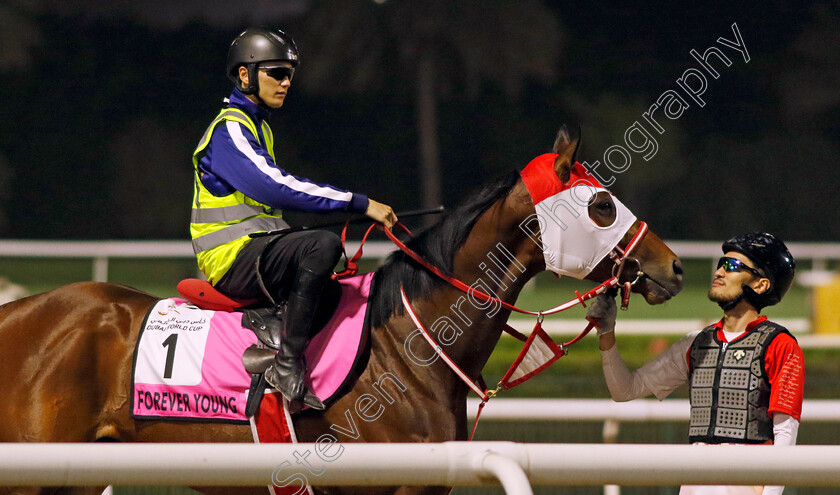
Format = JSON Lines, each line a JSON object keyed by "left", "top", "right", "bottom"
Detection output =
{"left": 368, "top": 170, "right": 519, "bottom": 328}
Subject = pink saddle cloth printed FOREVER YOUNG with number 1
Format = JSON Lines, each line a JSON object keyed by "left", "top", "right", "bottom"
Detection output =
{"left": 131, "top": 273, "right": 373, "bottom": 423}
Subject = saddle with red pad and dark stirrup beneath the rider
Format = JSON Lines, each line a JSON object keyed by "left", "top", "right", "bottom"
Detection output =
{"left": 177, "top": 279, "right": 350, "bottom": 417}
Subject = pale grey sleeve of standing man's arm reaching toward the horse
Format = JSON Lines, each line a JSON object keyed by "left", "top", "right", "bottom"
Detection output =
{"left": 601, "top": 332, "right": 699, "bottom": 402}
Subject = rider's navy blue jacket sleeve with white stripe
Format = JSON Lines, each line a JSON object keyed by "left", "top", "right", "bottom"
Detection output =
{"left": 203, "top": 121, "right": 368, "bottom": 213}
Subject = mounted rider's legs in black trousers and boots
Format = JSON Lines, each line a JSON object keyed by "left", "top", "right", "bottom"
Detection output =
{"left": 216, "top": 230, "right": 342, "bottom": 411}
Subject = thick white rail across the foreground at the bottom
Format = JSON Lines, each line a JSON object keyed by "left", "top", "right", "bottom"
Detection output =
{"left": 0, "top": 442, "right": 840, "bottom": 495}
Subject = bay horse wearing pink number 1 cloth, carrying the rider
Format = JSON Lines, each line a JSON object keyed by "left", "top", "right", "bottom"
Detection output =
{"left": 0, "top": 126, "right": 682, "bottom": 494}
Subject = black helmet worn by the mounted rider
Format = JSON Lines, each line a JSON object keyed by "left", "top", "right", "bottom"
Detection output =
{"left": 227, "top": 27, "right": 298, "bottom": 95}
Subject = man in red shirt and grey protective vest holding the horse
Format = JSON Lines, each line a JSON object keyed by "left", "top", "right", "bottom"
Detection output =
{"left": 587, "top": 233, "right": 805, "bottom": 495}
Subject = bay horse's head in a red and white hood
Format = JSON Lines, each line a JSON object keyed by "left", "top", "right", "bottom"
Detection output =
{"left": 522, "top": 126, "right": 682, "bottom": 304}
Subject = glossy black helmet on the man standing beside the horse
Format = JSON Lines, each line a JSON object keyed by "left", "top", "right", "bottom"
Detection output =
{"left": 722, "top": 232, "right": 796, "bottom": 311}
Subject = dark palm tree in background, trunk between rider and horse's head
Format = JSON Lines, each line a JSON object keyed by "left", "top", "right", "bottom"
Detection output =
{"left": 299, "top": 0, "right": 562, "bottom": 215}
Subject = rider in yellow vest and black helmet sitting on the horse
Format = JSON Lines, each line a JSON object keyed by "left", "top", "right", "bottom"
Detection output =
{"left": 190, "top": 28, "right": 397, "bottom": 410}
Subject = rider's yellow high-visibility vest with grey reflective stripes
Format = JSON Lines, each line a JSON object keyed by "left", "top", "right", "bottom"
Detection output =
{"left": 190, "top": 108, "right": 289, "bottom": 284}
